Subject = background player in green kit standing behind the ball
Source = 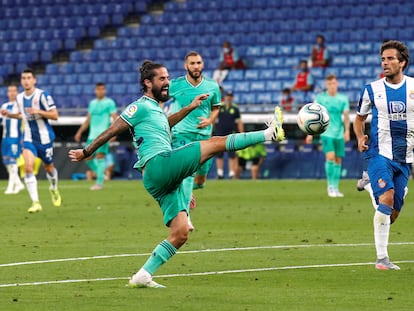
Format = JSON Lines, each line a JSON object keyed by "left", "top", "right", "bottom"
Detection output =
{"left": 306, "top": 74, "right": 350, "bottom": 197}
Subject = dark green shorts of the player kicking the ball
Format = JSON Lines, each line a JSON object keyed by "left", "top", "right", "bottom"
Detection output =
{"left": 143, "top": 142, "right": 201, "bottom": 226}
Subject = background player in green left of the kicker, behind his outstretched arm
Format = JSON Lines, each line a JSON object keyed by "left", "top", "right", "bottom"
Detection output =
{"left": 75, "top": 82, "right": 118, "bottom": 190}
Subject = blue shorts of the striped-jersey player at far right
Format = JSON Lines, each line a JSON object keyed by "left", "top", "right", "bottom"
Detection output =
{"left": 368, "top": 155, "right": 411, "bottom": 211}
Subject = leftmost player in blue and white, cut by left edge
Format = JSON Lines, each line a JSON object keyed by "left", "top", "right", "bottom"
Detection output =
{"left": 0, "top": 85, "right": 24, "bottom": 194}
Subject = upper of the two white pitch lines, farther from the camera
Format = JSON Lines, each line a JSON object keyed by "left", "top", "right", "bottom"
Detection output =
{"left": 0, "top": 242, "right": 414, "bottom": 268}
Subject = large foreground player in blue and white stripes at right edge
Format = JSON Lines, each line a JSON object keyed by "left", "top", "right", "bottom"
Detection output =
{"left": 354, "top": 40, "right": 414, "bottom": 270}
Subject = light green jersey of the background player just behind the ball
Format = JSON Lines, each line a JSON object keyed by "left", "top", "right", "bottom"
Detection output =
{"left": 316, "top": 92, "right": 349, "bottom": 138}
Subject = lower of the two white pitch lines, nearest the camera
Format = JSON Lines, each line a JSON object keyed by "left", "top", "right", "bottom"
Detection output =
{"left": 0, "top": 260, "right": 414, "bottom": 288}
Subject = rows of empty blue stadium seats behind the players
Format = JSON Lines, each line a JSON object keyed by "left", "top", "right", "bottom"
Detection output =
{"left": 0, "top": 0, "right": 414, "bottom": 114}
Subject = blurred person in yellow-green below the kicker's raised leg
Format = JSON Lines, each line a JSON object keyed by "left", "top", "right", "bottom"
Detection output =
{"left": 236, "top": 144, "right": 266, "bottom": 180}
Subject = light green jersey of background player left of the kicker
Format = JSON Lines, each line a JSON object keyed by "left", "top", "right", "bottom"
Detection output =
{"left": 88, "top": 97, "right": 116, "bottom": 140}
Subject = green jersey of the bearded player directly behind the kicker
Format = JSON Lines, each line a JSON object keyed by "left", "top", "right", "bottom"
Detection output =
{"left": 169, "top": 76, "right": 221, "bottom": 135}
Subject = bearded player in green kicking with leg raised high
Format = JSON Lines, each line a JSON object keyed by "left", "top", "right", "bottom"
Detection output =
{"left": 69, "top": 61, "right": 285, "bottom": 288}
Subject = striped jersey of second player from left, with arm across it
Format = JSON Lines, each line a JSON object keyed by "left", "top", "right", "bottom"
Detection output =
{"left": 16, "top": 88, "right": 56, "bottom": 145}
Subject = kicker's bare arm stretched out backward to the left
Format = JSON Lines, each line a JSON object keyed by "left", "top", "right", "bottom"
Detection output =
{"left": 68, "top": 117, "right": 129, "bottom": 162}
